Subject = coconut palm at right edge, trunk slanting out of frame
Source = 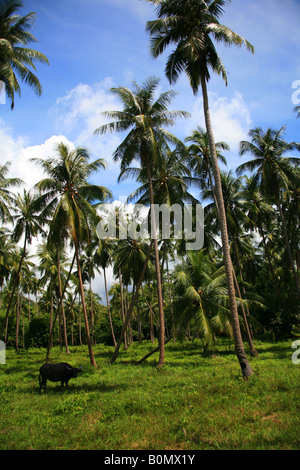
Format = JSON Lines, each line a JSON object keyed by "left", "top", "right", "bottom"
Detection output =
{"left": 237, "top": 127, "right": 300, "bottom": 299}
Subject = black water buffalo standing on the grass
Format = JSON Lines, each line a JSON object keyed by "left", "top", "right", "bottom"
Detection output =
{"left": 39, "top": 362, "right": 82, "bottom": 390}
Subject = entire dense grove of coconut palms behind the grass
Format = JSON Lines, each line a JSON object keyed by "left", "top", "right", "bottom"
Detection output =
{"left": 0, "top": 0, "right": 300, "bottom": 376}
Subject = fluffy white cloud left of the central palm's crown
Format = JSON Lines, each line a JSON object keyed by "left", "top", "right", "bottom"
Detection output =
{"left": 0, "top": 78, "right": 127, "bottom": 200}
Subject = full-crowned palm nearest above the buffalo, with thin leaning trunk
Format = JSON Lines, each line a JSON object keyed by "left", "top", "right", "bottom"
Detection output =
{"left": 33, "top": 143, "right": 111, "bottom": 366}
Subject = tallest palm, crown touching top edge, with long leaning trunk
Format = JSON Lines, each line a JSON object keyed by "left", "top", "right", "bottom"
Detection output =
{"left": 147, "top": 0, "right": 254, "bottom": 377}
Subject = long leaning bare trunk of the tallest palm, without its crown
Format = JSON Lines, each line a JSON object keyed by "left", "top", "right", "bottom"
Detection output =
{"left": 201, "top": 74, "right": 253, "bottom": 377}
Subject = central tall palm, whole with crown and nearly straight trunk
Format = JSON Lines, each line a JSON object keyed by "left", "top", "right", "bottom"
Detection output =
{"left": 95, "top": 77, "right": 188, "bottom": 367}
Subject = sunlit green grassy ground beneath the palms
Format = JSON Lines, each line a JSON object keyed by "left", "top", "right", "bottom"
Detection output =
{"left": 0, "top": 341, "right": 300, "bottom": 450}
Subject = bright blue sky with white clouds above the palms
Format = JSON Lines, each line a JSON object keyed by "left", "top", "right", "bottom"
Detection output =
{"left": 0, "top": 0, "right": 300, "bottom": 294}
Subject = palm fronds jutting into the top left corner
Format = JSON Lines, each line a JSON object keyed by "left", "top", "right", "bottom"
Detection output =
{"left": 0, "top": 0, "right": 49, "bottom": 109}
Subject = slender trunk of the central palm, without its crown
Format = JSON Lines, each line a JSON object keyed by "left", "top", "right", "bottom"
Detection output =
{"left": 146, "top": 158, "right": 165, "bottom": 367}
